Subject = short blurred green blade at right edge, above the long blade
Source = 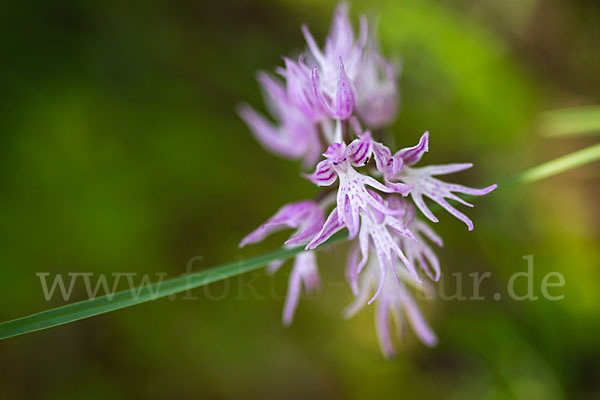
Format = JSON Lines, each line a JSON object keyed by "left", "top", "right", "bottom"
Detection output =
{"left": 538, "top": 106, "right": 600, "bottom": 137}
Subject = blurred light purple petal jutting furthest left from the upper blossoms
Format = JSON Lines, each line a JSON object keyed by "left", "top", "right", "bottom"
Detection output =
{"left": 237, "top": 104, "right": 305, "bottom": 159}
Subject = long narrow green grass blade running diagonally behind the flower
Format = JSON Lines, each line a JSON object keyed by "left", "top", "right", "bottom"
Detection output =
{"left": 0, "top": 144, "right": 600, "bottom": 339}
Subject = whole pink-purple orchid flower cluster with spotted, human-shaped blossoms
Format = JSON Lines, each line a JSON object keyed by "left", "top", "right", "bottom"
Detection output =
{"left": 238, "top": 4, "right": 496, "bottom": 356}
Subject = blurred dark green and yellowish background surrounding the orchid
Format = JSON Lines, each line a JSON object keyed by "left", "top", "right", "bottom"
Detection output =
{"left": 0, "top": 0, "right": 600, "bottom": 399}
